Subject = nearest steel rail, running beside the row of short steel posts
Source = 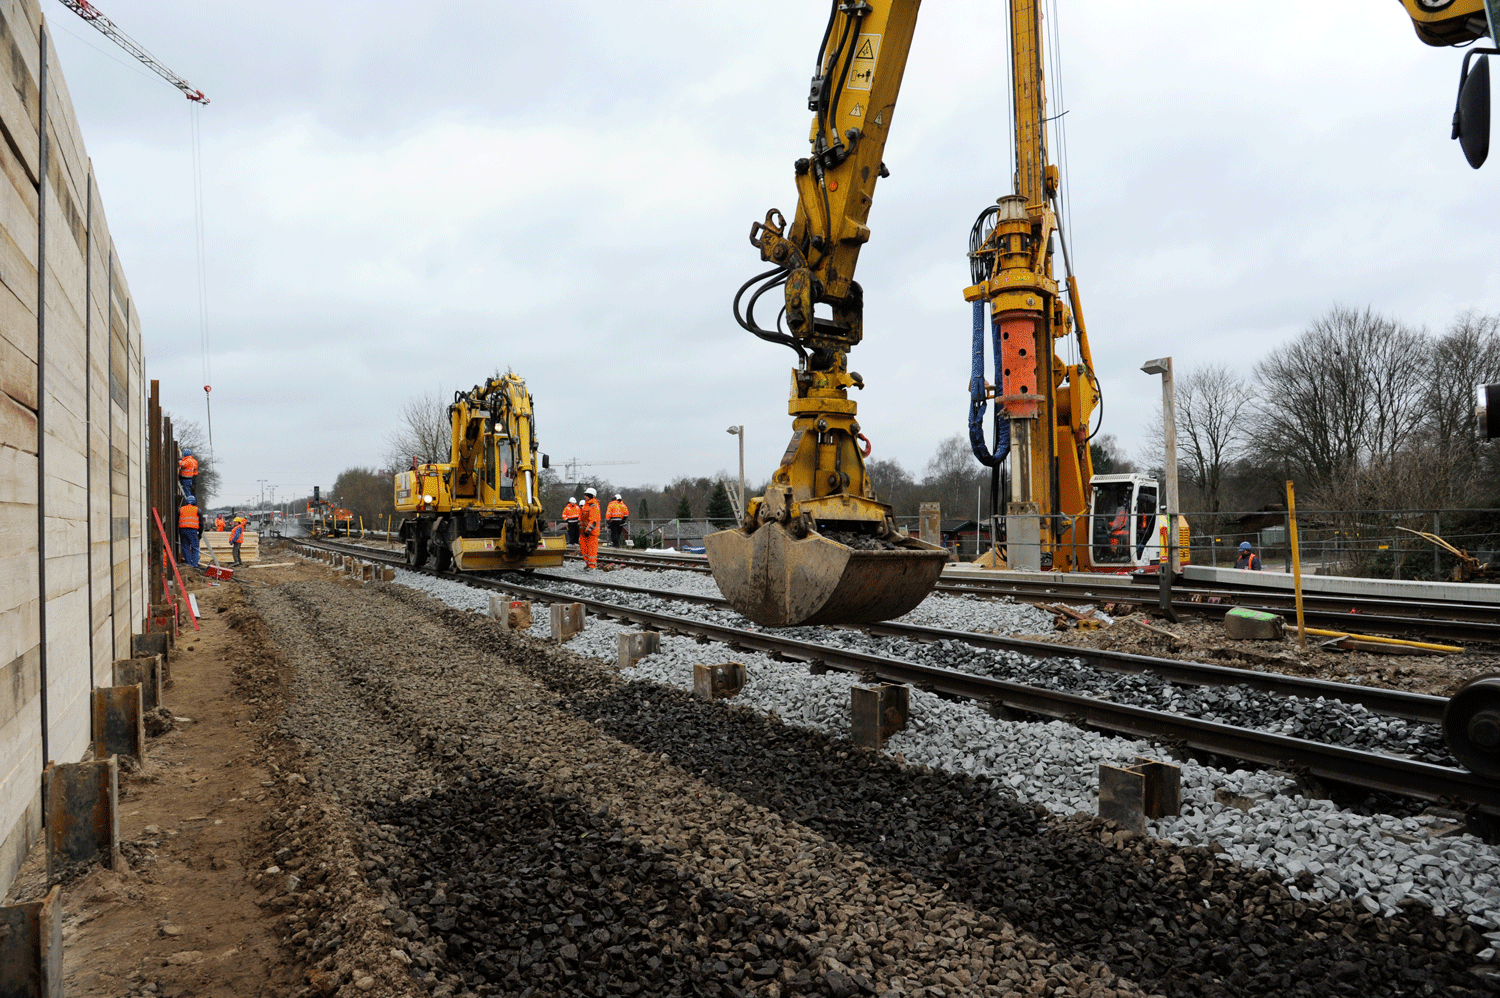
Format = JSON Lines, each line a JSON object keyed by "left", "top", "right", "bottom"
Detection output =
{"left": 283, "top": 539, "right": 1500, "bottom": 815}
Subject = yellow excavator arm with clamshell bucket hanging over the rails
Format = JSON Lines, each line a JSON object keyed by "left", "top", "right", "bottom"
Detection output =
{"left": 705, "top": 0, "right": 947, "bottom": 626}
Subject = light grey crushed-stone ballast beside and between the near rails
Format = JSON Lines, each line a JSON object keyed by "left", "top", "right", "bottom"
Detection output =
{"left": 401, "top": 572, "right": 1500, "bottom": 960}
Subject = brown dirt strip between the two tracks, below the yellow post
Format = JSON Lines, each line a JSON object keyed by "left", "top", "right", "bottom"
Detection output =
{"left": 1043, "top": 611, "right": 1500, "bottom": 696}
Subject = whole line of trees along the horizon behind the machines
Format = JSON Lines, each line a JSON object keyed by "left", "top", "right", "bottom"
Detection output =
{"left": 319, "top": 305, "right": 1500, "bottom": 561}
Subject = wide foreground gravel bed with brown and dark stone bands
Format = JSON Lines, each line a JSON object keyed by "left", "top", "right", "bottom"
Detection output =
{"left": 254, "top": 564, "right": 1494, "bottom": 995}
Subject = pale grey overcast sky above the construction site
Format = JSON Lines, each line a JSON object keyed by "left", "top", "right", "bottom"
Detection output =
{"left": 44, "top": 0, "right": 1500, "bottom": 501}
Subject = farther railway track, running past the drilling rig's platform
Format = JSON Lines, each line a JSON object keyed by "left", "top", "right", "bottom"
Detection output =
{"left": 579, "top": 551, "right": 1500, "bottom": 644}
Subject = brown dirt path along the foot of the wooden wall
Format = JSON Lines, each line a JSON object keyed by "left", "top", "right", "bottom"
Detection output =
{"left": 8, "top": 561, "right": 327, "bottom": 996}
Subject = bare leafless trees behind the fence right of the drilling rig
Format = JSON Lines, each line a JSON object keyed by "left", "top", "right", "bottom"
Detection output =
{"left": 1146, "top": 305, "right": 1500, "bottom": 512}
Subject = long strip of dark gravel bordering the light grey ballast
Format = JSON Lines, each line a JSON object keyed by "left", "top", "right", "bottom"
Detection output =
{"left": 575, "top": 672, "right": 1488, "bottom": 996}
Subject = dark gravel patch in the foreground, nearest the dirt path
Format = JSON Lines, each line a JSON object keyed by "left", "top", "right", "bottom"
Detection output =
{"left": 374, "top": 771, "right": 834, "bottom": 995}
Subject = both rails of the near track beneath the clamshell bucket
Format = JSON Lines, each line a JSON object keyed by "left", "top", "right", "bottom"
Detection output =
{"left": 282, "top": 540, "right": 1500, "bottom": 819}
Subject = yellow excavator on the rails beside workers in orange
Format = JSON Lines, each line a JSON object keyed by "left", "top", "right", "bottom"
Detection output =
{"left": 395, "top": 374, "right": 567, "bottom": 572}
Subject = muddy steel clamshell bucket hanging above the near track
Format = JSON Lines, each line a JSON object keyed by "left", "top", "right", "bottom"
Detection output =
{"left": 704, "top": 524, "right": 948, "bottom": 627}
